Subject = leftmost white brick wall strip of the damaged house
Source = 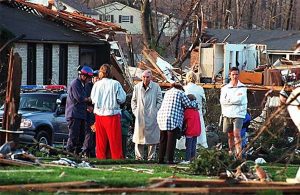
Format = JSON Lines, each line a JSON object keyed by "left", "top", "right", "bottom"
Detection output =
{"left": 14, "top": 43, "right": 27, "bottom": 85}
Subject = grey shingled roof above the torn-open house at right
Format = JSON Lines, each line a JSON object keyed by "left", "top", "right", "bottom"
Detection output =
{"left": 205, "top": 29, "right": 300, "bottom": 50}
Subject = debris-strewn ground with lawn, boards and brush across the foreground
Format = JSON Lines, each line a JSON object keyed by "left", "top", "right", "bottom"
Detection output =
{"left": 0, "top": 89, "right": 300, "bottom": 193}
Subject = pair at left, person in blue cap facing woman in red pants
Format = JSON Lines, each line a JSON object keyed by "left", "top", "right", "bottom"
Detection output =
{"left": 66, "top": 64, "right": 126, "bottom": 159}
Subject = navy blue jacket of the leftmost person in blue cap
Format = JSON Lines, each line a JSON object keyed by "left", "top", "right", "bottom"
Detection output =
{"left": 66, "top": 78, "right": 87, "bottom": 120}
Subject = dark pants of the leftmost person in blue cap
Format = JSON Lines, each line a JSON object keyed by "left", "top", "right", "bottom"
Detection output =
{"left": 67, "top": 118, "right": 85, "bottom": 154}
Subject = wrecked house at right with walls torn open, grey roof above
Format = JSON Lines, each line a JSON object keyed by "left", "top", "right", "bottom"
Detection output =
{"left": 190, "top": 29, "right": 300, "bottom": 86}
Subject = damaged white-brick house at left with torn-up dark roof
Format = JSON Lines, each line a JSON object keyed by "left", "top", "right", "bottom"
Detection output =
{"left": 0, "top": 0, "right": 125, "bottom": 85}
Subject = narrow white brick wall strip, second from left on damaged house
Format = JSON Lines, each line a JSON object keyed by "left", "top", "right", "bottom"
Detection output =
{"left": 36, "top": 44, "right": 44, "bottom": 85}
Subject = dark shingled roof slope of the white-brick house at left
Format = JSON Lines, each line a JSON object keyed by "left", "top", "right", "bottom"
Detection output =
{"left": 0, "top": 3, "right": 106, "bottom": 44}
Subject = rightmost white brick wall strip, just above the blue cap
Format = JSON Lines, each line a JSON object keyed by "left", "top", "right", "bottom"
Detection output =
{"left": 68, "top": 45, "right": 79, "bottom": 85}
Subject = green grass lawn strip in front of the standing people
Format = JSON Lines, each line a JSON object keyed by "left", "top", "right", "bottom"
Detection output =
{"left": 0, "top": 160, "right": 298, "bottom": 187}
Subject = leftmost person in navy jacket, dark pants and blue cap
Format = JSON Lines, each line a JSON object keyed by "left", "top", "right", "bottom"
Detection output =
{"left": 66, "top": 66, "right": 93, "bottom": 154}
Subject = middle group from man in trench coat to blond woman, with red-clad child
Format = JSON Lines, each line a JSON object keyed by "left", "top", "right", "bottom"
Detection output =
{"left": 131, "top": 70, "right": 207, "bottom": 164}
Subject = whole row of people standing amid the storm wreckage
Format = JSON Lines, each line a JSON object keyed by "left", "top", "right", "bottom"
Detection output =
{"left": 66, "top": 64, "right": 247, "bottom": 164}
